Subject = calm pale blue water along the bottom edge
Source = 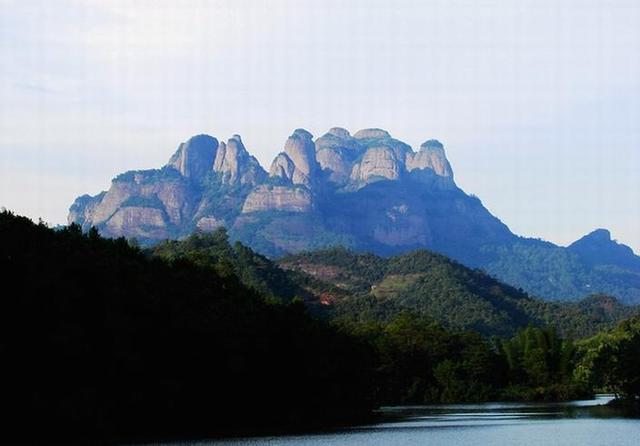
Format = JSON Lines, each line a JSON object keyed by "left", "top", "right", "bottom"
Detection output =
{"left": 160, "top": 395, "right": 640, "bottom": 446}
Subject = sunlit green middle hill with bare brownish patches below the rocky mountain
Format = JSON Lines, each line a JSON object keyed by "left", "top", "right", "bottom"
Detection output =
{"left": 280, "top": 248, "right": 637, "bottom": 337}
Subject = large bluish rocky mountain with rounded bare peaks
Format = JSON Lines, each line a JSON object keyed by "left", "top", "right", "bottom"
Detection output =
{"left": 69, "top": 127, "right": 640, "bottom": 303}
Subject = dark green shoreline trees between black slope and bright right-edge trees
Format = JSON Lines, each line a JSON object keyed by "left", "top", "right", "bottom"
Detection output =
{"left": 345, "top": 313, "right": 591, "bottom": 405}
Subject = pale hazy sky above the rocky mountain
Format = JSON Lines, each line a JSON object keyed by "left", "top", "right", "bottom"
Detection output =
{"left": 0, "top": 0, "right": 640, "bottom": 253}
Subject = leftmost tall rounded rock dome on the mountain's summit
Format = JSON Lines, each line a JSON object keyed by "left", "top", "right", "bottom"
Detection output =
{"left": 168, "top": 135, "right": 218, "bottom": 180}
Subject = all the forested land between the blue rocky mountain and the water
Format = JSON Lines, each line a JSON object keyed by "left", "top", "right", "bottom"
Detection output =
{"left": 0, "top": 212, "right": 640, "bottom": 442}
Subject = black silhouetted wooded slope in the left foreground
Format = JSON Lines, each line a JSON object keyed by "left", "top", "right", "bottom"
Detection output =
{"left": 0, "top": 212, "right": 373, "bottom": 443}
